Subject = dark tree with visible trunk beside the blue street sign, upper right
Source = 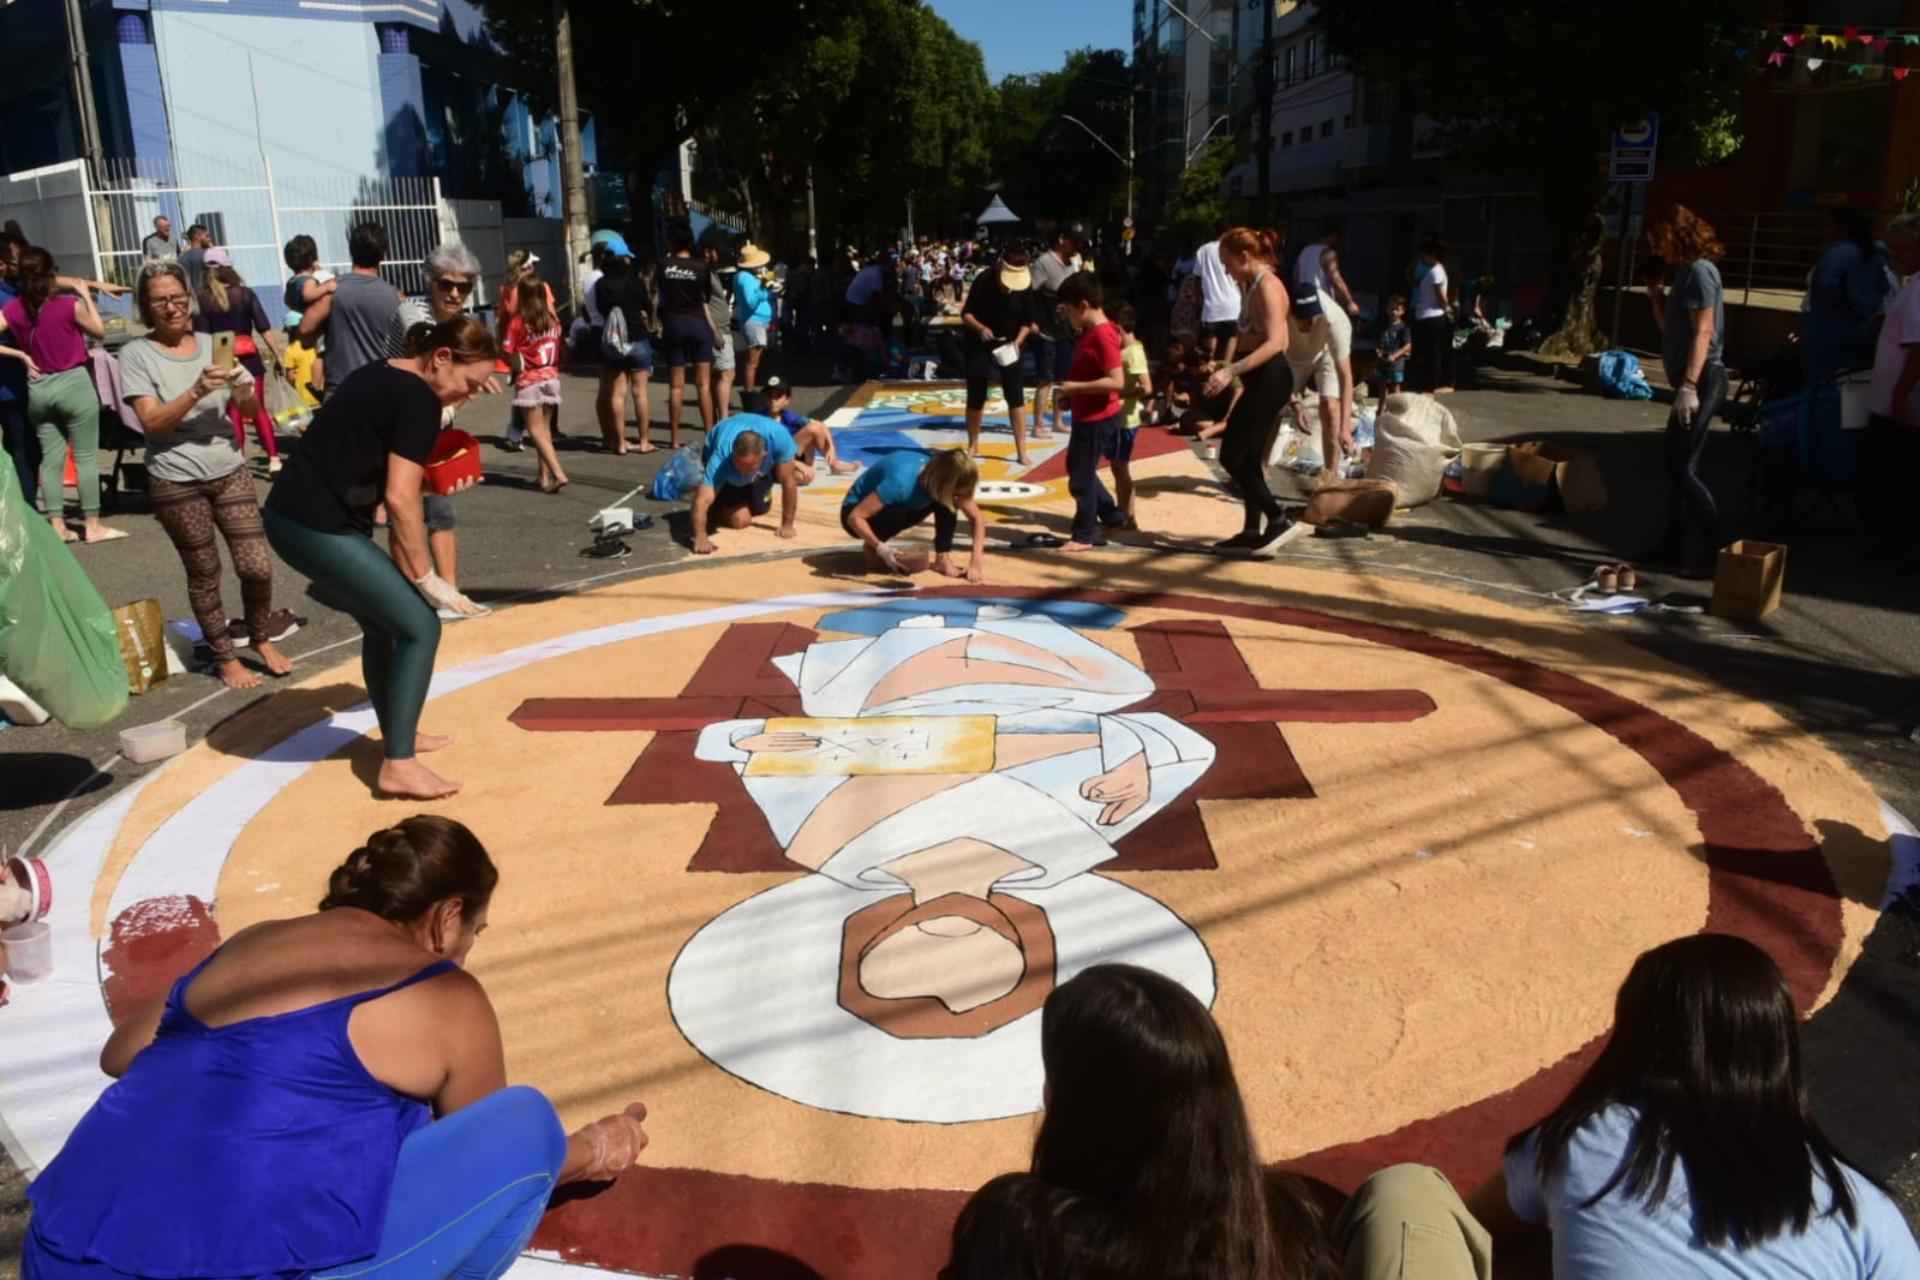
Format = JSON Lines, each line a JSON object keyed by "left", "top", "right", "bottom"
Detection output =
{"left": 1319, "top": 0, "right": 1774, "bottom": 355}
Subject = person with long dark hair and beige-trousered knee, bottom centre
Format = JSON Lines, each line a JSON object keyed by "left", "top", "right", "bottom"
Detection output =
{"left": 943, "top": 965, "right": 1492, "bottom": 1280}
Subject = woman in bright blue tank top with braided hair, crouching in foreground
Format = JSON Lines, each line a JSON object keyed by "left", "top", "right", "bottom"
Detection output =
{"left": 21, "top": 821, "right": 647, "bottom": 1280}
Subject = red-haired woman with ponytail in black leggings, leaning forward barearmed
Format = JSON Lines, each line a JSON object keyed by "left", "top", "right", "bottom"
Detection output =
{"left": 1202, "top": 226, "right": 1306, "bottom": 558}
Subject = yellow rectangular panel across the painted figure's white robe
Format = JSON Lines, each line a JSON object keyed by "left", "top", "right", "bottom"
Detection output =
{"left": 737, "top": 716, "right": 995, "bottom": 777}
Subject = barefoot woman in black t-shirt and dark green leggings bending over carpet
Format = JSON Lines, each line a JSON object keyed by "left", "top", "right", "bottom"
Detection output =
{"left": 265, "top": 315, "right": 499, "bottom": 800}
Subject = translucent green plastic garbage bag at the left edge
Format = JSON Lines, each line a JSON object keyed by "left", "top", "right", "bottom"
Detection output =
{"left": 0, "top": 451, "right": 127, "bottom": 729}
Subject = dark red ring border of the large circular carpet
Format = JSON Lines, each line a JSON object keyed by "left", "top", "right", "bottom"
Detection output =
{"left": 97, "top": 587, "right": 1843, "bottom": 1280}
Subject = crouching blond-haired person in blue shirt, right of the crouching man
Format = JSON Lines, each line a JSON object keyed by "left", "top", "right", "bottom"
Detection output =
{"left": 841, "top": 449, "right": 987, "bottom": 581}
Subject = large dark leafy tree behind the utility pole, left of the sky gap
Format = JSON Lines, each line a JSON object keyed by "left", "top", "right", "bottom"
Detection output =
{"left": 486, "top": 0, "right": 995, "bottom": 248}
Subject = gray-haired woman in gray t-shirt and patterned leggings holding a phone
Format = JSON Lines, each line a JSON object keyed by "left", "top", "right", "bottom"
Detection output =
{"left": 119, "top": 259, "right": 294, "bottom": 689}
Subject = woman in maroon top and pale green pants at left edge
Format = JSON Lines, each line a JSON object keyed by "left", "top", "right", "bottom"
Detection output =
{"left": 0, "top": 248, "right": 127, "bottom": 543}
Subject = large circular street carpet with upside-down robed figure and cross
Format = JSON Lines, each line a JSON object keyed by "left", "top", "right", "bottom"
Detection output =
{"left": 0, "top": 553, "right": 1887, "bottom": 1278}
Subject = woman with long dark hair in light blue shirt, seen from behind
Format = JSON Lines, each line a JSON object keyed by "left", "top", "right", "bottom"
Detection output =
{"left": 1471, "top": 933, "right": 1920, "bottom": 1280}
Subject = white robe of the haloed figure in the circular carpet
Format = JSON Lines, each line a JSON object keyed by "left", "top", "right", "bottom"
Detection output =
{"left": 697, "top": 606, "right": 1215, "bottom": 892}
